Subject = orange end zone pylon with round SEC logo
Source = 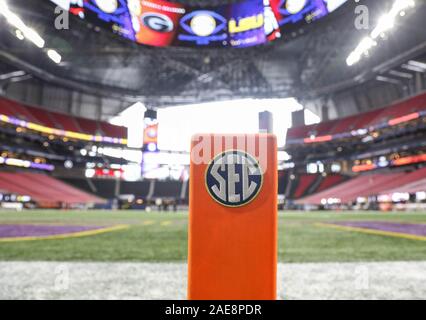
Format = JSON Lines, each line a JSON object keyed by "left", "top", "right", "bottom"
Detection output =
{"left": 188, "top": 134, "right": 278, "bottom": 300}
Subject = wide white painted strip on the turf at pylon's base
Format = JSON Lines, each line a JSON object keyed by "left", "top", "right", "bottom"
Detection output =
{"left": 0, "top": 262, "right": 426, "bottom": 299}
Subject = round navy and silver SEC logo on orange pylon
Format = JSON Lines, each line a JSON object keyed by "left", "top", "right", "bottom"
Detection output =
{"left": 205, "top": 150, "right": 263, "bottom": 207}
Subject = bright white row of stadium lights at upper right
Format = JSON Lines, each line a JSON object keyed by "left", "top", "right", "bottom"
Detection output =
{"left": 346, "top": 0, "right": 415, "bottom": 67}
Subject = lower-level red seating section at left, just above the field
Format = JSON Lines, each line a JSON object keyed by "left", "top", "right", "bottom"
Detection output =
{"left": 0, "top": 172, "right": 104, "bottom": 204}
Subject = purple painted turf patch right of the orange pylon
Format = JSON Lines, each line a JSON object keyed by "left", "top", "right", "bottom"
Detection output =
{"left": 333, "top": 221, "right": 426, "bottom": 236}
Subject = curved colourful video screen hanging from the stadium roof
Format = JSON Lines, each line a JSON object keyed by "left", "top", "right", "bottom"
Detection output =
{"left": 50, "top": 0, "right": 347, "bottom": 48}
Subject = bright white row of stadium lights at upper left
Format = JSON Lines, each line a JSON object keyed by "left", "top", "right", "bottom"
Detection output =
{"left": 0, "top": 0, "right": 62, "bottom": 64}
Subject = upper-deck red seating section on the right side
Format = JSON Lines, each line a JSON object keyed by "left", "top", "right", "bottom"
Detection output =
{"left": 287, "top": 94, "right": 426, "bottom": 140}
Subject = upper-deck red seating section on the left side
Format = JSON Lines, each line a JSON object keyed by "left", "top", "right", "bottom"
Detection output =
{"left": 0, "top": 98, "right": 127, "bottom": 139}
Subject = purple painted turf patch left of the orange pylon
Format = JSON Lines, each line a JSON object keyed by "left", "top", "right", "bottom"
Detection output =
{"left": 0, "top": 224, "right": 104, "bottom": 239}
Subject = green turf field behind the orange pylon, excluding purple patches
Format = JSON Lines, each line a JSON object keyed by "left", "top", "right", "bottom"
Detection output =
{"left": 0, "top": 211, "right": 426, "bottom": 262}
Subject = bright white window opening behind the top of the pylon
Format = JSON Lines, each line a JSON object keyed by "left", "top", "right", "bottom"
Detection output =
{"left": 158, "top": 98, "right": 306, "bottom": 151}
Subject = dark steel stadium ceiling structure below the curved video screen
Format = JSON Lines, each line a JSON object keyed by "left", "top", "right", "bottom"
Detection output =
{"left": 0, "top": 0, "right": 426, "bottom": 118}
